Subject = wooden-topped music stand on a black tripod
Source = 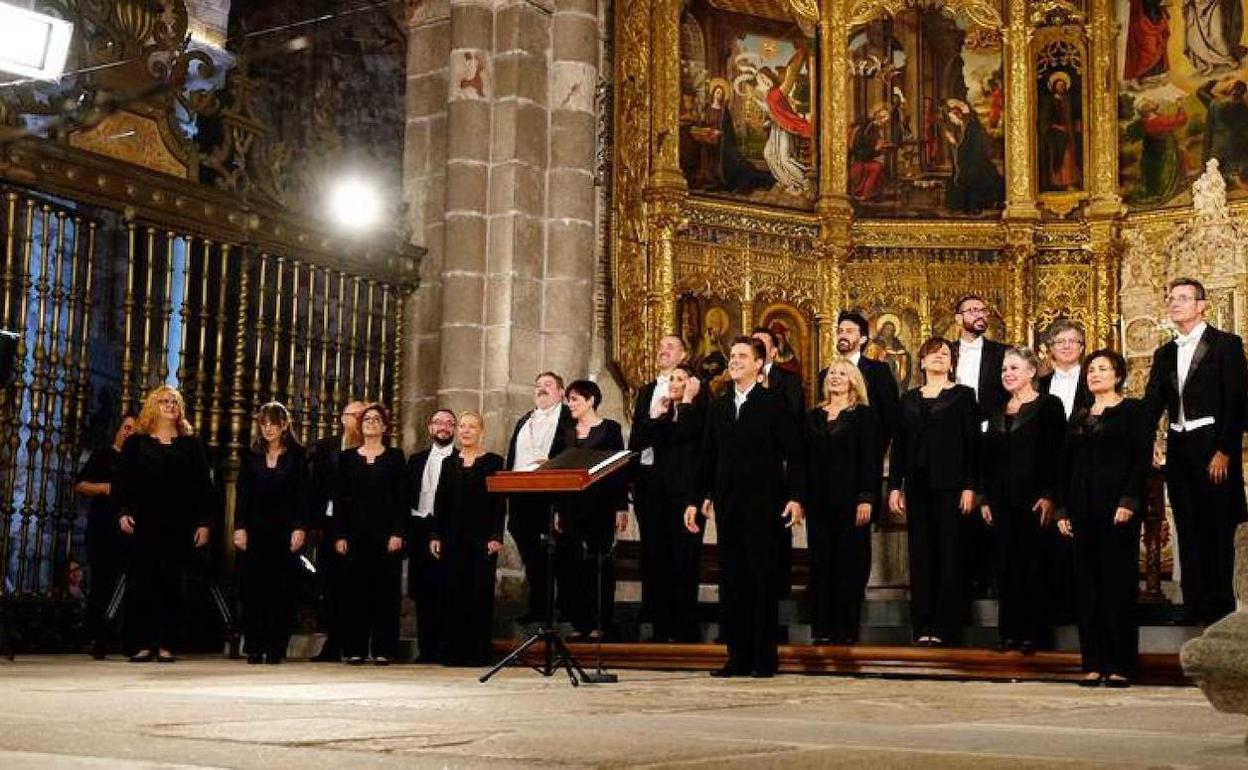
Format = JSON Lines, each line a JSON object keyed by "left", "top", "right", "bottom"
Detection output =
{"left": 478, "top": 448, "right": 633, "bottom": 686}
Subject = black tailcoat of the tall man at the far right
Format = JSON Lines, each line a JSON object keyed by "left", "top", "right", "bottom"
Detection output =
{"left": 1144, "top": 326, "right": 1248, "bottom": 456}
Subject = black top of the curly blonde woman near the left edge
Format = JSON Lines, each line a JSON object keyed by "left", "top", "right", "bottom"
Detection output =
{"left": 112, "top": 433, "right": 218, "bottom": 544}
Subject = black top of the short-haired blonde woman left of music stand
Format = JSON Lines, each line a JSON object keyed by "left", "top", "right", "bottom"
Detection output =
{"left": 429, "top": 449, "right": 507, "bottom": 553}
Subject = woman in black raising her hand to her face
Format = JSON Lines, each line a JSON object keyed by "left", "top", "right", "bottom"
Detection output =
{"left": 651, "top": 363, "right": 706, "bottom": 643}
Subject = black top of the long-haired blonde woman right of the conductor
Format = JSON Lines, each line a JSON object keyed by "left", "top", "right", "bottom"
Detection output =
{"left": 805, "top": 404, "right": 881, "bottom": 512}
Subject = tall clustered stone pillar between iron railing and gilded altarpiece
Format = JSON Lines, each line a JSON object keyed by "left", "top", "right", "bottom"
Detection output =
{"left": 403, "top": 0, "right": 606, "bottom": 451}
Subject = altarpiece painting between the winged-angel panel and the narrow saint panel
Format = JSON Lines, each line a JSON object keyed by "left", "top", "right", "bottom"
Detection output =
{"left": 849, "top": 0, "right": 1005, "bottom": 218}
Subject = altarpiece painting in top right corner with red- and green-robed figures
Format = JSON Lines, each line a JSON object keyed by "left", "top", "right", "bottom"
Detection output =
{"left": 1117, "top": 0, "right": 1248, "bottom": 208}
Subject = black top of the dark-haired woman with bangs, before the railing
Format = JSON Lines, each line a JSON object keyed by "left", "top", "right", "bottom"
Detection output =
{"left": 235, "top": 446, "right": 311, "bottom": 543}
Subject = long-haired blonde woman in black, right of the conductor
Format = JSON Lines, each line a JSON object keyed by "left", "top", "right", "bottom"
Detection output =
{"left": 805, "top": 358, "right": 881, "bottom": 644}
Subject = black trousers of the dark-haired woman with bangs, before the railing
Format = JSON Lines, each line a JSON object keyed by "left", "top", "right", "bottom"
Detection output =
{"left": 240, "top": 538, "right": 297, "bottom": 659}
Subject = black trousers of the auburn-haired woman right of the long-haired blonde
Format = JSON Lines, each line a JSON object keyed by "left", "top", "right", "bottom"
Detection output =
{"left": 906, "top": 479, "right": 966, "bottom": 641}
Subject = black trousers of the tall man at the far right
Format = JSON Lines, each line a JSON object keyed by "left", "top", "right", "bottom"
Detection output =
{"left": 1166, "top": 427, "right": 1244, "bottom": 623}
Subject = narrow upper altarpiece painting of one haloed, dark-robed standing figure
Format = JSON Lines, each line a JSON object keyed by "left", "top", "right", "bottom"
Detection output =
{"left": 1035, "top": 35, "right": 1086, "bottom": 200}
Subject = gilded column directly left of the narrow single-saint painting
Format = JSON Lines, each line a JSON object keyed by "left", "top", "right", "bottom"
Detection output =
{"left": 1003, "top": 0, "right": 1038, "bottom": 220}
